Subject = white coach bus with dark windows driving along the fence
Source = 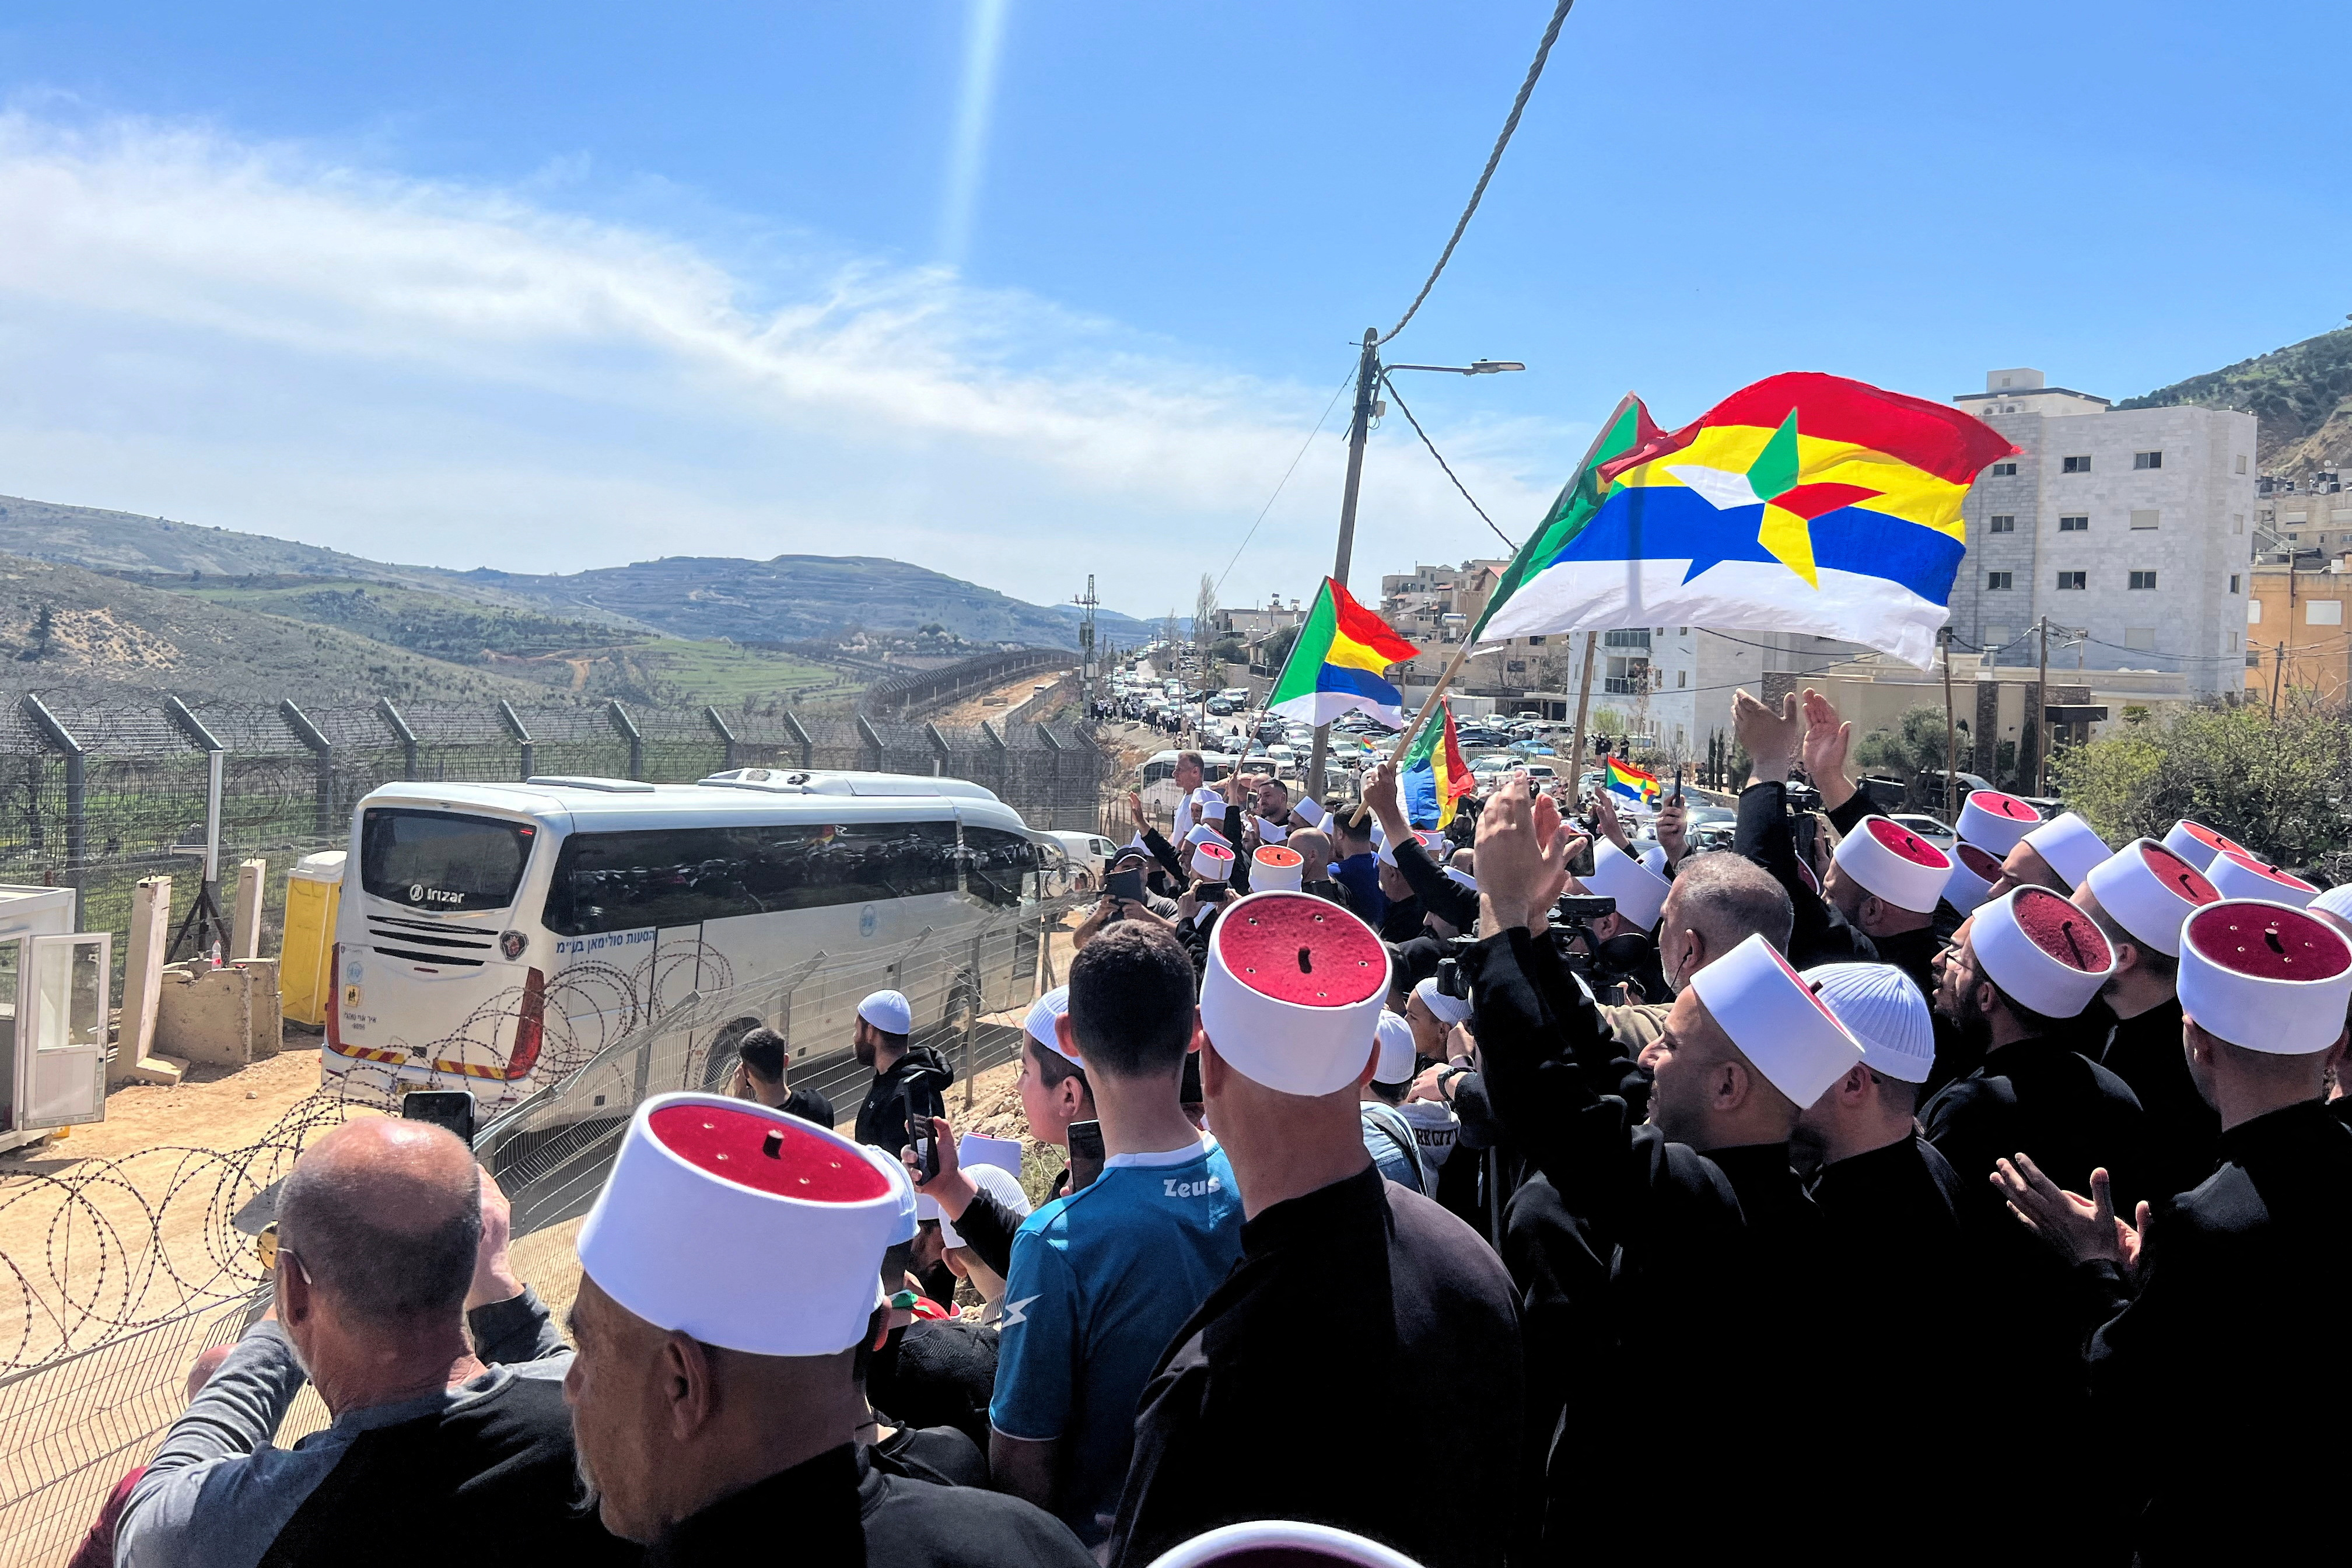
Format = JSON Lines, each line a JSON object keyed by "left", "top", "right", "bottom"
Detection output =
{"left": 320, "top": 769, "right": 1068, "bottom": 1119}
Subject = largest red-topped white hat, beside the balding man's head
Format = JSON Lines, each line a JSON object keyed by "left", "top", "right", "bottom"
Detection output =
{"left": 576, "top": 1093, "right": 915, "bottom": 1356}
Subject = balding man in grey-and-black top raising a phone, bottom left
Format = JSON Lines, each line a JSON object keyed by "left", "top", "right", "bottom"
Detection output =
{"left": 116, "top": 1112, "right": 635, "bottom": 1568}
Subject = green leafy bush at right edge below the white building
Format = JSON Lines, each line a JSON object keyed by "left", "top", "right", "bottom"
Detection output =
{"left": 2051, "top": 698, "right": 2352, "bottom": 867}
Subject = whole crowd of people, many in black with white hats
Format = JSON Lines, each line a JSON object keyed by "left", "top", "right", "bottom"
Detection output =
{"left": 92, "top": 694, "right": 2352, "bottom": 1568}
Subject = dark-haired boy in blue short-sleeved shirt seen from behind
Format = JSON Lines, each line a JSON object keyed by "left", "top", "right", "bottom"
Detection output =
{"left": 988, "top": 922, "right": 1242, "bottom": 1547}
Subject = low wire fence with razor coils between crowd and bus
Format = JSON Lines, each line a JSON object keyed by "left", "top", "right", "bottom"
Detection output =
{"left": 0, "top": 898, "right": 1073, "bottom": 1568}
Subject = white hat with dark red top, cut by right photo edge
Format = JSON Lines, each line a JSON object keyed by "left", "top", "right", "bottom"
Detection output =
{"left": 2180, "top": 898, "right": 2352, "bottom": 1055}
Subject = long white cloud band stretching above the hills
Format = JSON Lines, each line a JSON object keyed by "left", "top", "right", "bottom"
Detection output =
{"left": 0, "top": 113, "right": 1573, "bottom": 614}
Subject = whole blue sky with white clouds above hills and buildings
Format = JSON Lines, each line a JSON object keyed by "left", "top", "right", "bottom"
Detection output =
{"left": 0, "top": 0, "right": 2352, "bottom": 614}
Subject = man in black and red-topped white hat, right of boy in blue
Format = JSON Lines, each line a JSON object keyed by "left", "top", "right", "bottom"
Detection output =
{"left": 1108, "top": 893, "right": 1520, "bottom": 1568}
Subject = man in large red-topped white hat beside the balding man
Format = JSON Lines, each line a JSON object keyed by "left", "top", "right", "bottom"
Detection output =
{"left": 564, "top": 1093, "right": 1089, "bottom": 1568}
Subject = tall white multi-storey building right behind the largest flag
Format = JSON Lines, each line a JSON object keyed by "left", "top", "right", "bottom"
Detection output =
{"left": 1952, "top": 369, "right": 2256, "bottom": 694}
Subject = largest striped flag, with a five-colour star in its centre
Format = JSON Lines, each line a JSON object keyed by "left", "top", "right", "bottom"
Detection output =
{"left": 1475, "top": 372, "right": 2015, "bottom": 665}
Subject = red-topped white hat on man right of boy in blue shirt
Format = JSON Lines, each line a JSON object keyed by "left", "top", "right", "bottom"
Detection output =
{"left": 1199, "top": 893, "right": 1390, "bottom": 1096}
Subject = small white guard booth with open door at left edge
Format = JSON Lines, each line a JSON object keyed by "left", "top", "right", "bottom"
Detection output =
{"left": 0, "top": 886, "right": 116, "bottom": 1147}
